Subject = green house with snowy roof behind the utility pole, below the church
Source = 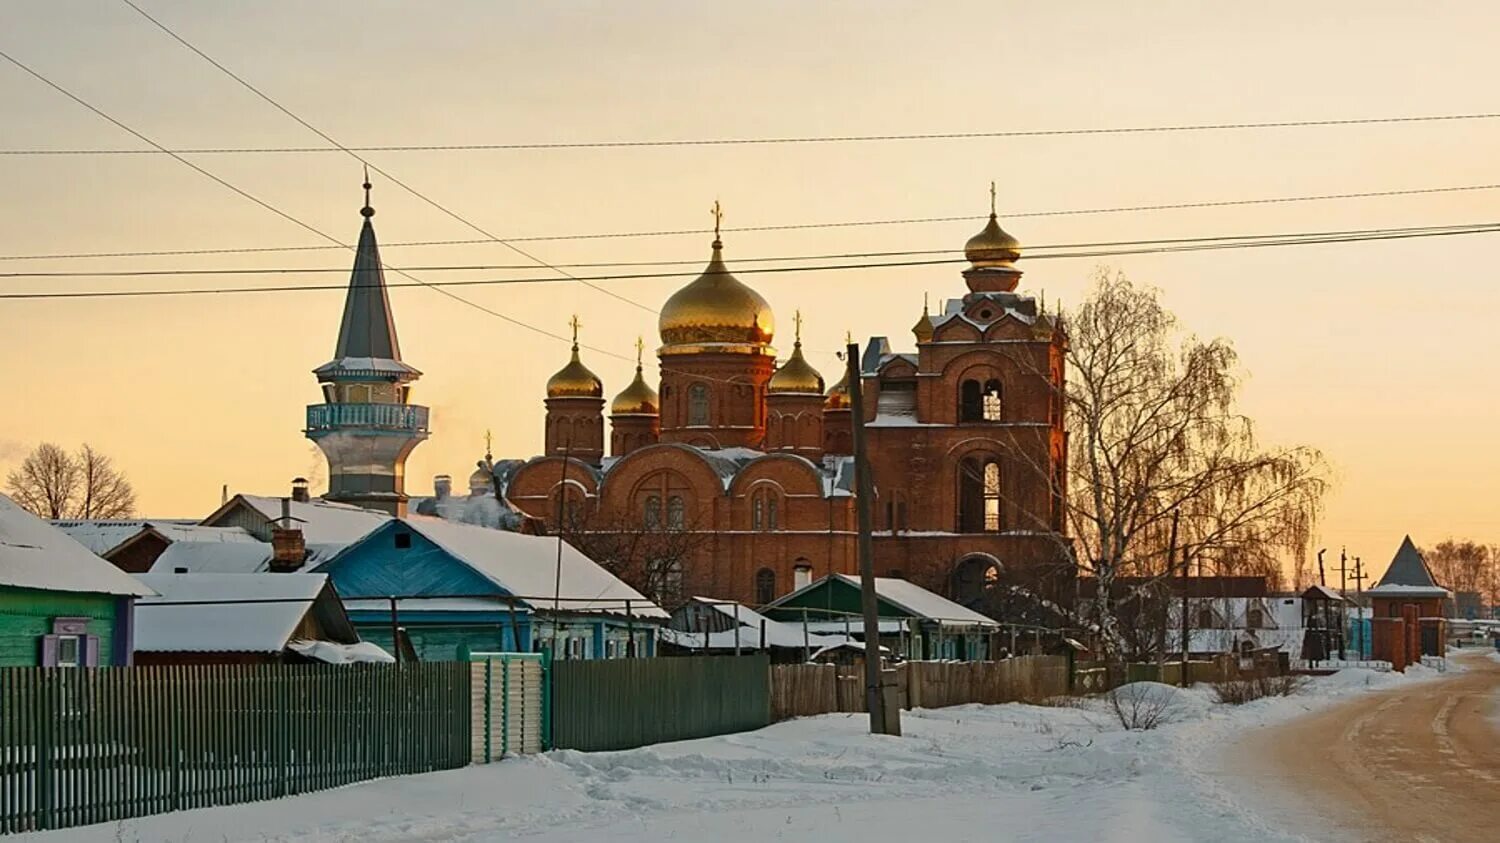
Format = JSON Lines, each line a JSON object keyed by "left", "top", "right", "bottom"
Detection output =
{"left": 762, "top": 573, "right": 1001, "bottom": 662}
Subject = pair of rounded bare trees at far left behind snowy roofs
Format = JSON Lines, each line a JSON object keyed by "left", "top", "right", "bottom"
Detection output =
{"left": 6, "top": 443, "right": 135, "bottom": 519}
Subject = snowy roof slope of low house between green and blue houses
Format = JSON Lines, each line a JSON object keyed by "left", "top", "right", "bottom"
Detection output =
{"left": 135, "top": 573, "right": 329, "bottom": 653}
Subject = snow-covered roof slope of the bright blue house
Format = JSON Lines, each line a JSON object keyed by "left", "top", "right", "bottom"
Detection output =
{"left": 402, "top": 516, "right": 668, "bottom": 618}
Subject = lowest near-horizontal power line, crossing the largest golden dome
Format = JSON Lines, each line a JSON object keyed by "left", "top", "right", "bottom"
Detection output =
{"left": 0, "top": 222, "right": 1500, "bottom": 300}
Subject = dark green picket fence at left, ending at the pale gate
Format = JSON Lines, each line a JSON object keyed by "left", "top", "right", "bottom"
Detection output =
{"left": 0, "top": 662, "right": 470, "bottom": 833}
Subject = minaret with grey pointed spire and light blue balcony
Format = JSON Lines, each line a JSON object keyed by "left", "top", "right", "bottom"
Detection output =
{"left": 303, "top": 174, "right": 428, "bottom": 516}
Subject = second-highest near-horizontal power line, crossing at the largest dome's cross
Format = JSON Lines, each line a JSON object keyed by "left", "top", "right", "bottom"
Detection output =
{"left": 11, "top": 183, "right": 1500, "bottom": 261}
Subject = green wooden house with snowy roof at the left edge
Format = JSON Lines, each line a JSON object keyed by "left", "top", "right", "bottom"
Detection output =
{"left": 0, "top": 495, "right": 153, "bottom": 668}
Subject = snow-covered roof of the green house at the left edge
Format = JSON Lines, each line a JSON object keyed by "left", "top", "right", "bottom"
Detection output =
{"left": 0, "top": 495, "right": 152, "bottom": 596}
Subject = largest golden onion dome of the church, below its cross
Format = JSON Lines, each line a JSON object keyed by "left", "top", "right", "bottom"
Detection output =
{"left": 657, "top": 239, "right": 776, "bottom": 354}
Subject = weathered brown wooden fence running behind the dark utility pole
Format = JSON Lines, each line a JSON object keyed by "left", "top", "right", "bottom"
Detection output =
{"left": 771, "top": 656, "right": 1068, "bottom": 720}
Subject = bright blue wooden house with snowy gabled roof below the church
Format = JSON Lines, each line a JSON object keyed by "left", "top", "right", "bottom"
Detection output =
{"left": 317, "top": 516, "right": 668, "bottom": 662}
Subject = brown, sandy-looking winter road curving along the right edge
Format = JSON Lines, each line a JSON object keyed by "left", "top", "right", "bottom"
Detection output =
{"left": 1239, "top": 654, "right": 1500, "bottom": 843}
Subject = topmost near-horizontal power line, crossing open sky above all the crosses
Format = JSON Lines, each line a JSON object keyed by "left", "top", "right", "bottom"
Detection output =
{"left": 11, "top": 111, "right": 1500, "bottom": 156}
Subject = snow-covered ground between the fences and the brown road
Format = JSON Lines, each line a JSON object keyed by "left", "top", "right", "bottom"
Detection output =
{"left": 15, "top": 668, "right": 1436, "bottom": 843}
